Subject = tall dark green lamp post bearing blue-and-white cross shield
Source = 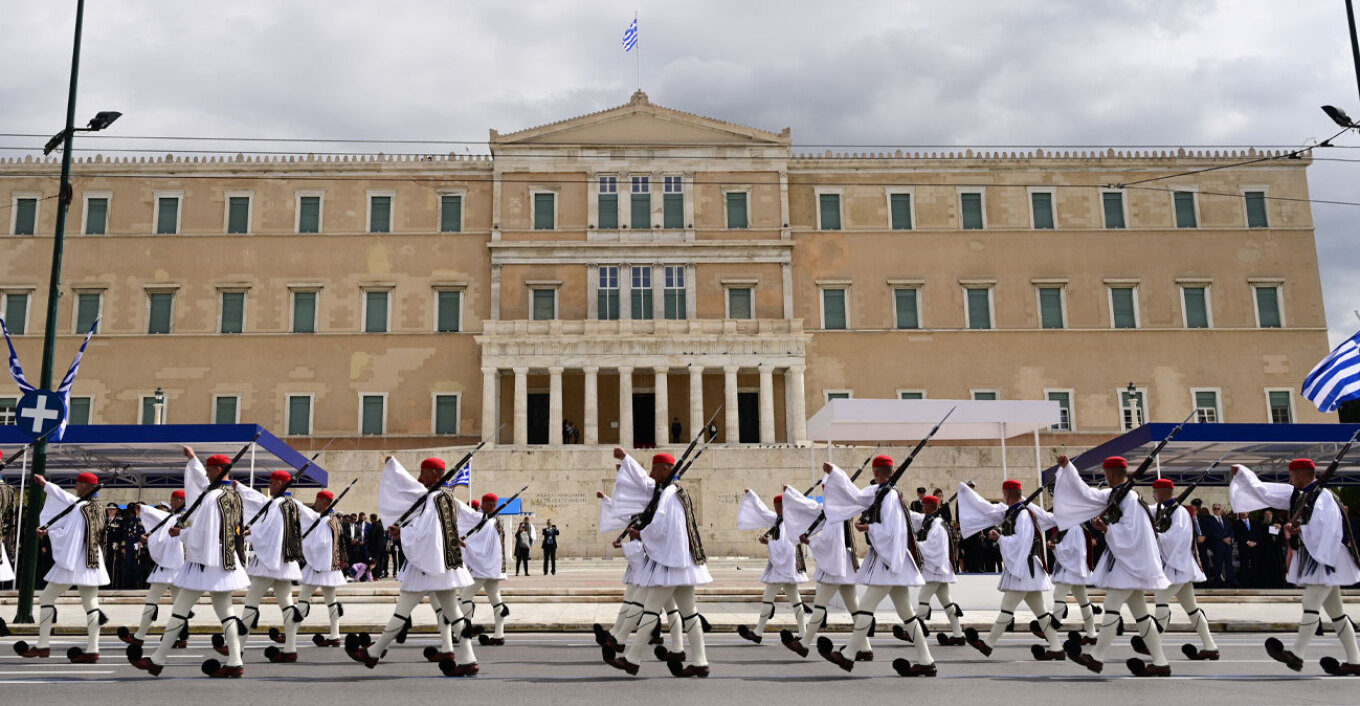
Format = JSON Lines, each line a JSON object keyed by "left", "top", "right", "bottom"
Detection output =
{"left": 14, "top": 0, "right": 122, "bottom": 623}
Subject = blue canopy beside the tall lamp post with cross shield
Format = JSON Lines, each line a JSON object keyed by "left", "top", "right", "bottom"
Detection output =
{"left": 0, "top": 424, "right": 328, "bottom": 488}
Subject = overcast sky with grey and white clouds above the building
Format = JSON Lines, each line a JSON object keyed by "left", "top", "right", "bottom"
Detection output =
{"left": 0, "top": 0, "right": 1360, "bottom": 343}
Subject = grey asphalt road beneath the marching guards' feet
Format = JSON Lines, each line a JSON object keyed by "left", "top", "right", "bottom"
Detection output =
{"left": 0, "top": 633, "right": 1360, "bottom": 706}
